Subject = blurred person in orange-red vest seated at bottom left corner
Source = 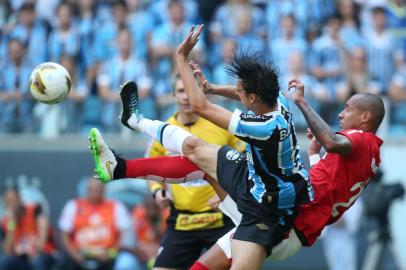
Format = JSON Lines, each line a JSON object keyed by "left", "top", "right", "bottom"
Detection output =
{"left": 0, "top": 187, "right": 54, "bottom": 270}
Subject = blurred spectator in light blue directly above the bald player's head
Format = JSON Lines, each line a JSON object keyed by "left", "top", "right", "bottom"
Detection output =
{"left": 366, "top": 7, "right": 403, "bottom": 93}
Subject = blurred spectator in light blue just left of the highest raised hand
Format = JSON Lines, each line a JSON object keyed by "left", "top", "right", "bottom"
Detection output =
{"left": 151, "top": 0, "right": 201, "bottom": 119}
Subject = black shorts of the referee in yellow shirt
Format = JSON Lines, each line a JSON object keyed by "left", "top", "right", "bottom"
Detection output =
{"left": 154, "top": 226, "right": 231, "bottom": 269}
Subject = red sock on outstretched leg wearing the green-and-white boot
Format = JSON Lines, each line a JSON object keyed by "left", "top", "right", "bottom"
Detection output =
{"left": 124, "top": 156, "right": 205, "bottom": 184}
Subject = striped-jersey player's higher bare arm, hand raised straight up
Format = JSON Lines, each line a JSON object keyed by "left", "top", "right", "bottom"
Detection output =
{"left": 176, "top": 25, "right": 232, "bottom": 129}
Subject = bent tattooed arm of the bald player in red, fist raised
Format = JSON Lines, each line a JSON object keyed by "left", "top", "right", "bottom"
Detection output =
{"left": 288, "top": 79, "right": 352, "bottom": 155}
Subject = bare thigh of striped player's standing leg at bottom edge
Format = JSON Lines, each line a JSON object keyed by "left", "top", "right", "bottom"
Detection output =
{"left": 231, "top": 239, "right": 266, "bottom": 270}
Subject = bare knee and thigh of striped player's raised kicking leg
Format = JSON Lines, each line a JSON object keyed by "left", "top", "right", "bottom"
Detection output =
{"left": 183, "top": 136, "right": 221, "bottom": 180}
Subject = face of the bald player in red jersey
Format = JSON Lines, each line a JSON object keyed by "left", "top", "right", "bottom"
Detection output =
{"left": 338, "top": 96, "right": 362, "bottom": 130}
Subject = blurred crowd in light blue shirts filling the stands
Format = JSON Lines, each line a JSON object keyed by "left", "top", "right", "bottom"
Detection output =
{"left": 0, "top": 0, "right": 406, "bottom": 137}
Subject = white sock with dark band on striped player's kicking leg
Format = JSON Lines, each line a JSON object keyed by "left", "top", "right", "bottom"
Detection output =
{"left": 128, "top": 115, "right": 192, "bottom": 155}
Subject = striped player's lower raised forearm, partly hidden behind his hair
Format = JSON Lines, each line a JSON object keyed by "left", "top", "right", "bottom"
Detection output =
{"left": 189, "top": 61, "right": 240, "bottom": 101}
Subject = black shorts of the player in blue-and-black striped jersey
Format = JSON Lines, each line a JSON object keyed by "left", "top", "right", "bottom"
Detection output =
{"left": 217, "top": 146, "right": 296, "bottom": 256}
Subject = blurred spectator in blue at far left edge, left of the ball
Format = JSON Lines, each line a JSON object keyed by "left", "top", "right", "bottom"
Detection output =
{"left": 0, "top": 39, "right": 33, "bottom": 132}
